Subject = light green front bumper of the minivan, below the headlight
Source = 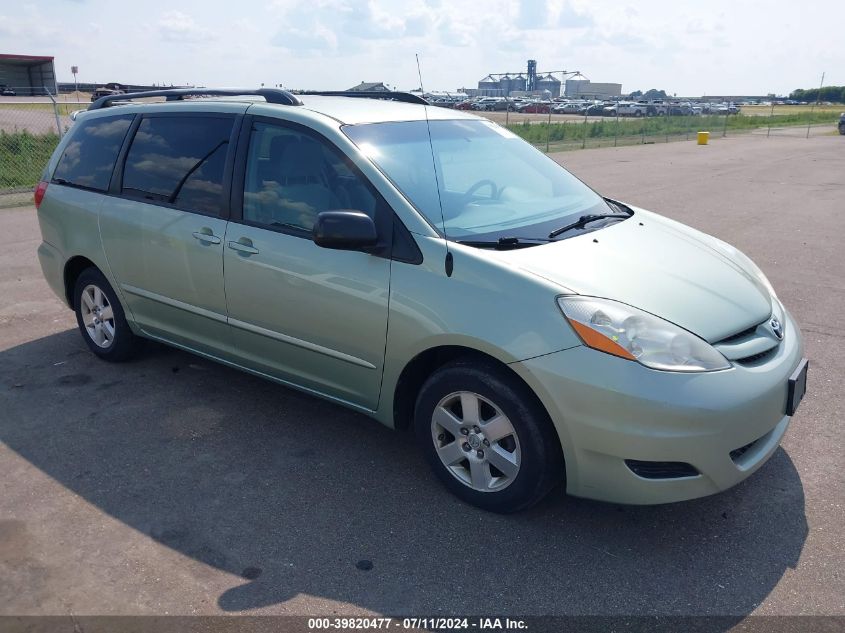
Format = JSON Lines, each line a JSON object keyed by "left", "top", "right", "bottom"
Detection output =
{"left": 511, "top": 315, "right": 803, "bottom": 504}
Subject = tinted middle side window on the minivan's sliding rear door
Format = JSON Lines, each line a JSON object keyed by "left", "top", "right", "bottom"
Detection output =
{"left": 121, "top": 116, "right": 233, "bottom": 215}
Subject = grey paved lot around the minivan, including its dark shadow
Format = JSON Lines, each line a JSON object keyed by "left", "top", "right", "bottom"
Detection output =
{"left": 0, "top": 136, "right": 845, "bottom": 617}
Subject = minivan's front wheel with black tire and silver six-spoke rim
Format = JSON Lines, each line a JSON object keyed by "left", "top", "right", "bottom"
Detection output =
{"left": 414, "top": 357, "right": 565, "bottom": 513}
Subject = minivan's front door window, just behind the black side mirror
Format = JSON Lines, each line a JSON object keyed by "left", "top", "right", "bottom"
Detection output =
{"left": 243, "top": 122, "right": 376, "bottom": 231}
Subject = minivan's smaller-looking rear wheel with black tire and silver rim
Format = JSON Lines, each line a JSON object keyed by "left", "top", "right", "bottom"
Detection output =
{"left": 73, "top": 268, "right": 143, "bottom": 362}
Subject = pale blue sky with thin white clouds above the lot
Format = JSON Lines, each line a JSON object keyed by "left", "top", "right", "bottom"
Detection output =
{"left": 0, "top": 0, "right": 845, "bottom": 96}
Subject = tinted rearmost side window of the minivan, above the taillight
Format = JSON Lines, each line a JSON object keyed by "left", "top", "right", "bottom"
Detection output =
{"left": 53, "top": 114, "right": 132, "bottom": 191}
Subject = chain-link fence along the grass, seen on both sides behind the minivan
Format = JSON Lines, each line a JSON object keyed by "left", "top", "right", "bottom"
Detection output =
{"left": 0, "top": 91, "right": 845, "bottom": 207}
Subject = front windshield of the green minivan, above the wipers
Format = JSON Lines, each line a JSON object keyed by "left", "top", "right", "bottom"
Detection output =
{"left": 343, "top": 120, "right": 611, "bottom": 240}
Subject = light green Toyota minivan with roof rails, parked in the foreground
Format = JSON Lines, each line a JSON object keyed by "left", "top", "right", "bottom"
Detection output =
{"left": 35, "top": 89, "right": 808, "bottom": 512}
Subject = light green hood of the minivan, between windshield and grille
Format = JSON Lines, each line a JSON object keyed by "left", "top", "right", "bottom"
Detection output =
{"left": 497, "top": 209, "right": 772, "bottom": 343}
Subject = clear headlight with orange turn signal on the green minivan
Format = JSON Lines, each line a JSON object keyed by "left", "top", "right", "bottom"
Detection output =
{"left": 557, "top": 295, "right": 731, "bottom": 371}
